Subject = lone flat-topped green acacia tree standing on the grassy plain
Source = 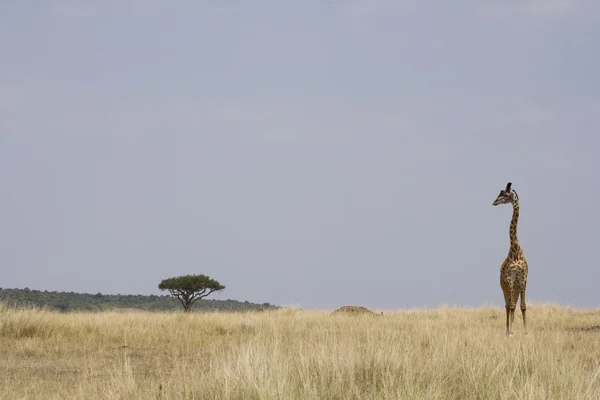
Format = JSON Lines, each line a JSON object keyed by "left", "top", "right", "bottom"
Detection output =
{"left": 158, "top": 275, "right": 225, "bottom": 312}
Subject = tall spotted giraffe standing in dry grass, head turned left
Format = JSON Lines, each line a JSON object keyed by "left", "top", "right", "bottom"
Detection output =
{"left": 492, "top": 182, "right": 528, "bottom": 337}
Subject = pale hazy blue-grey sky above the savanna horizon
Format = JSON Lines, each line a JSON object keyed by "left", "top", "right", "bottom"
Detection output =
{"left": 0, "top": 0, "right": 600, "bottom": 309}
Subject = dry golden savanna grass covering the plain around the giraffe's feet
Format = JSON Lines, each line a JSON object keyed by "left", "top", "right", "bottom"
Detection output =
{"left": 0, "top": 305, "right": 600, "bottom": 400}
